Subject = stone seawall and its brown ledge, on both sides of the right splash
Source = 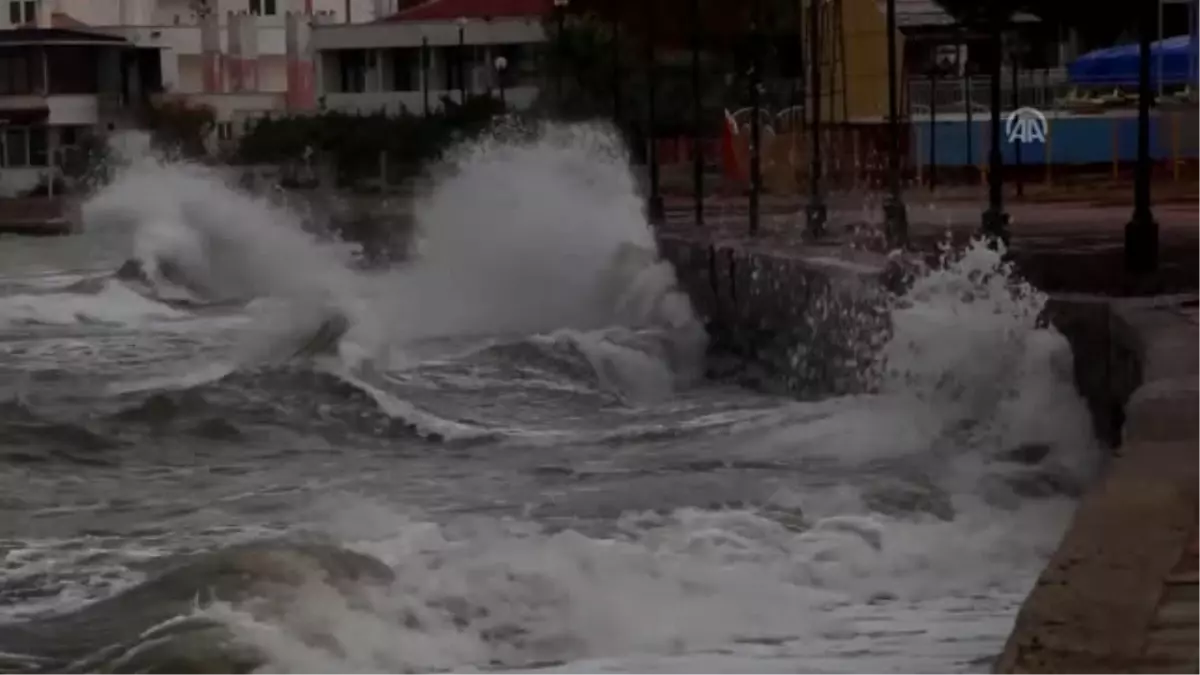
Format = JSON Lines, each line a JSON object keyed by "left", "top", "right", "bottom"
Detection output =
{"left": 660, "top": 229, "right": 1200, "bottom": 675}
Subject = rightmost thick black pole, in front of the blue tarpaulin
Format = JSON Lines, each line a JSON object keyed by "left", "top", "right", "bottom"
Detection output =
{"left": 1124, "top": 2, "right": 1158, "bottom": 275}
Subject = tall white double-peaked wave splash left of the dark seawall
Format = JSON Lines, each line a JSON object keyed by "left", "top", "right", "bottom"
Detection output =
{"left": 77, "top": 126, "right": 704, "bottom": 410}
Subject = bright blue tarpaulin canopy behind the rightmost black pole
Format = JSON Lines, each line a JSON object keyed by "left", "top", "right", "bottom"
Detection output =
{"left": 1067, "top": 35, "right": 1192, "bottom": 86}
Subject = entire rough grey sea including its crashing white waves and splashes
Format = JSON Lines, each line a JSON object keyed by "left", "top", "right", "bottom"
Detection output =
{"left": 0, "top": 129, "right": 1096, "bottom": 674}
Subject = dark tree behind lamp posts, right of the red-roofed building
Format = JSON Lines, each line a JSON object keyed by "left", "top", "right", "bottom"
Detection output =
{"left": 542, "top": 0, "right": 800, "bottom": 136}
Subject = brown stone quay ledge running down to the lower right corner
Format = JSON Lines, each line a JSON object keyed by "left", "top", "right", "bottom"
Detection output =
{"left": 995, "top": 295, "right": 1200, "bottom": 675}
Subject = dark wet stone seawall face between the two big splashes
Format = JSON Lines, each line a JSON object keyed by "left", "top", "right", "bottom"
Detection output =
{"left": 659, "top": 234, "right": 892, "bottom": 398}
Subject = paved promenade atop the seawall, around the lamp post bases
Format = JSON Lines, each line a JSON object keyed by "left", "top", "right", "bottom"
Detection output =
{"left": 662, "top": 196, "right": 1200, "bottom": 295}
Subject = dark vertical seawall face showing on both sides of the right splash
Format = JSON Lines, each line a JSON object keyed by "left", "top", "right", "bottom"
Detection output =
{"left": 659, "top": 233, "right": 1133, "bottom": 446}
